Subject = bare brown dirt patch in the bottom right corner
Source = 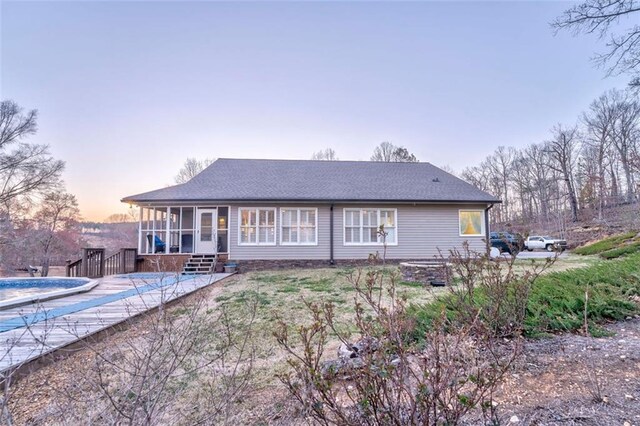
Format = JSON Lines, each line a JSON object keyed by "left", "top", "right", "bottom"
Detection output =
{"left": 496, "top": 318, "right": 640, "bottom": 426}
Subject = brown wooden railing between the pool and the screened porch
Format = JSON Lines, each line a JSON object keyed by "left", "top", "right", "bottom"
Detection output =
{"left": 66, "top": 248, "right": 138, "bottom": 278}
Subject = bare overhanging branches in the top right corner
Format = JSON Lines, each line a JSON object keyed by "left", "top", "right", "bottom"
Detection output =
{"left": 551, "top": 0, "right": 640, "bottom": 87}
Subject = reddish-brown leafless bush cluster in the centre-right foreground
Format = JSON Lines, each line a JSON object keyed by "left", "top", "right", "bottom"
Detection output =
{"left": 275, "top": 248, "right": 546, "bottom": 425}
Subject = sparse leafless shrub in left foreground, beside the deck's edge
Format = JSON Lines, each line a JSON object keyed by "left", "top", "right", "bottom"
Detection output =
{"left": 45, "top": 274, "right": 256, "bottom": 425}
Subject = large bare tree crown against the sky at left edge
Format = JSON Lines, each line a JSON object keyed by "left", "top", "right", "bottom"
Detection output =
{"left": 0, "top": 101, "right": 64, "bottom": 206}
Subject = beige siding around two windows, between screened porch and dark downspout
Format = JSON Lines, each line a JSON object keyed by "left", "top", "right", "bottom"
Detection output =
{"left": 229, "top": 203, "right": 330, "bottom": 261}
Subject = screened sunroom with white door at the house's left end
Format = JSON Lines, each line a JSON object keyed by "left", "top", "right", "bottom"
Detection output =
{"left": 138, "top": 206, "right": 229, "bottom": 254}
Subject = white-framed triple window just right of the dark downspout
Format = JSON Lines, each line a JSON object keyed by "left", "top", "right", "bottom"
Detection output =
{"left": 344, "top": 209, "right": 398, "bottom": 245}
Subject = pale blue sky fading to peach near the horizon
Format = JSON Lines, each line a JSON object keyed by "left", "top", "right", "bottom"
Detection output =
{"left": 0, "top": 0, "right": 628, "bottom": 220}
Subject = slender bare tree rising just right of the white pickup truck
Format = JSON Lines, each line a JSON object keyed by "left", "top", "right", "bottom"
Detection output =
{"left": 547, "top": 124, "right": 578, "bottom": 222}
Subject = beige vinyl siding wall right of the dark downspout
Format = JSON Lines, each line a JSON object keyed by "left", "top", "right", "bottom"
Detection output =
{"left": 334, "top": 204, "right": 486, "bottom": 259}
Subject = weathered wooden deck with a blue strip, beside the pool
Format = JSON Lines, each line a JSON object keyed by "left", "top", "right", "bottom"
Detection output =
{"left": 0, "top": 274, "right": 231, "bottom": 377}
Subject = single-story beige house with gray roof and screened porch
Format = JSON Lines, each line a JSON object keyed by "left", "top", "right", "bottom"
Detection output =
{"left": 122, "top": 158, "right": 500, "bottom": 269}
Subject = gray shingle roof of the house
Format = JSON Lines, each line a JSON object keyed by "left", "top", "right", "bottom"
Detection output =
{"left": 122, "top": 158, "right": 500, "bottom": 203}
